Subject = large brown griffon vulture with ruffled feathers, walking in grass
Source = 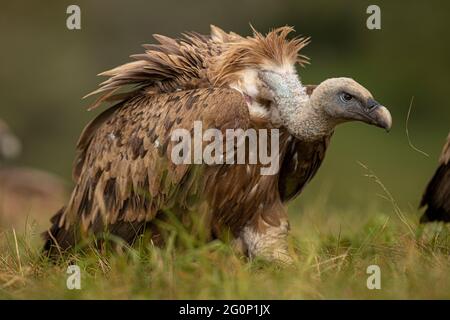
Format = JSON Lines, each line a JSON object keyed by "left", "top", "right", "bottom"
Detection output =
{"left": 44, "top": 27, "right": 391, "bottom": 262}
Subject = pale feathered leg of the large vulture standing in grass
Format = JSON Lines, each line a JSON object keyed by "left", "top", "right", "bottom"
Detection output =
{"left": 235, "top": 203, "right": 293, "bottom": 264}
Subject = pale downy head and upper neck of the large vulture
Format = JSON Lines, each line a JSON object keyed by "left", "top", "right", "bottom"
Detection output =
{"left": 285, "top": 78, "right": 392, "bottom": 140}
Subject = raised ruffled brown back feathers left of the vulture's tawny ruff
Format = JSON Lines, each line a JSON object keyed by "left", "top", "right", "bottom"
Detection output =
{"left": 86, "top": 33, "right": 218, "bottom": 108}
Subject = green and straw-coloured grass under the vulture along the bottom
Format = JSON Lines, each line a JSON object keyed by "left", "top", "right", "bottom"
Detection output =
{"left": 0, "top": 191, "right": 450, "bottom": 299}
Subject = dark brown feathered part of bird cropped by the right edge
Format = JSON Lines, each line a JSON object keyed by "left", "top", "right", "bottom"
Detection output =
{"left": 420, "top": 134, "right": 450, "bottom": 223}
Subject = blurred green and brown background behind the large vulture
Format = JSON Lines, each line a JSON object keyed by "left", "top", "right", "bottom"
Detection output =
{"left": 0, "top": 0, "right": 450, "bottom": 219}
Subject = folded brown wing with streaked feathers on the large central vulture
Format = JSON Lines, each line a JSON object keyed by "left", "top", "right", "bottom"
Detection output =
{"left": 45, "top": 88, "right": 249, "bottom": 250}
